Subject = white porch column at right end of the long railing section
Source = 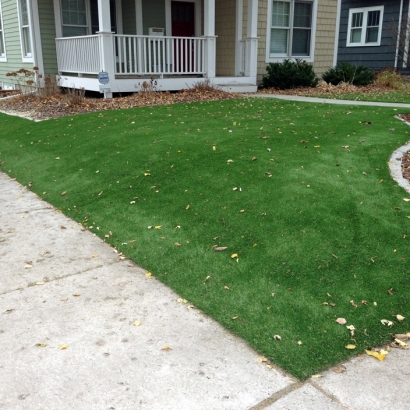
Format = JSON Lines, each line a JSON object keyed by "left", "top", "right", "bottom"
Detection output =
{"left": 204, "top": 0, "right": 216, "bottom": 78}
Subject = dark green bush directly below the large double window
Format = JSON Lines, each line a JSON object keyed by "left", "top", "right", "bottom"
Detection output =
{"left": 262, "top": 59, "right": 319, "bottom": 90}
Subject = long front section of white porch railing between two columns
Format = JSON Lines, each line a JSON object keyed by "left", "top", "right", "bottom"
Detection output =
{"left": 113, "top": 34, "right": 206, "bottom": 76}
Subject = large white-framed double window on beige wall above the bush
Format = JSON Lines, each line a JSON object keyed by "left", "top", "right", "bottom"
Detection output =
{"left": 267, "top": 0, "right": 315, "bottom": 61}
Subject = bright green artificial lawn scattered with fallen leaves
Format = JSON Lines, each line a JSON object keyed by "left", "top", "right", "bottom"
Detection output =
{"left": 0, "top": 99, "right": 410, "bottom": 379}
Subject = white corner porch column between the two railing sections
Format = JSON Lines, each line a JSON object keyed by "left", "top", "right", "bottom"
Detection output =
{"left": 97, "top": 0, "right": 115, "bottom": 98}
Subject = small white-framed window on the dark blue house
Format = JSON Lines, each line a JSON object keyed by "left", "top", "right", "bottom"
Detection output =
{"left": 346, "top": 6, "right": 383, "bottom": 47}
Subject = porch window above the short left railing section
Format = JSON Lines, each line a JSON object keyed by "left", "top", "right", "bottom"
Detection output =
{"left": 61, "top": 0, "right": 88, "bottom": 37}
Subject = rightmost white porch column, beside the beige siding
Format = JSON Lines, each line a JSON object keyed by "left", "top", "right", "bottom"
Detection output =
{"left": 245, "top": 0, "right": 258, "bottom": 80}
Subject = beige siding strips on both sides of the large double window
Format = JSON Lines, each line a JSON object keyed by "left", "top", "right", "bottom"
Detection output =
{"left": 256, "top": 0, "right": 337, "bottom": 82}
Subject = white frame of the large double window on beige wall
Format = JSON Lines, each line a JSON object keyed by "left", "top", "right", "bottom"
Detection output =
{"left": 266, "top": 0, "right": 318, "bottom": 63}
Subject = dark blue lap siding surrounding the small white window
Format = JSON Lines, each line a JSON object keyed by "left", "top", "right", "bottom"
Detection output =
{"left": 337, "top": 0, "right": 408, "bottom": 69}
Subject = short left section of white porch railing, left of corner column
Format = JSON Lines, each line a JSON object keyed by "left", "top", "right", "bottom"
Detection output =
{"left": 56, "top": 36, "right": 101, "bottom": 74}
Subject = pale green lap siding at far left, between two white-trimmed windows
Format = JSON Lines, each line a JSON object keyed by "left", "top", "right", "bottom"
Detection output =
{"left": 0, "top": 0, "right": 33, "bottom": 85}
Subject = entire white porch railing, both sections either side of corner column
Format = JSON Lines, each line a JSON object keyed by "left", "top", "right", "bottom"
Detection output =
{"left": 56, "top": 34, "right": 207, "bottom": 76}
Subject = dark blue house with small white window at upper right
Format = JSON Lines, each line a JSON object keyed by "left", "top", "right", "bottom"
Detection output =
{"left": 337, "top": 0, "right": 410, "bottom": 70}
